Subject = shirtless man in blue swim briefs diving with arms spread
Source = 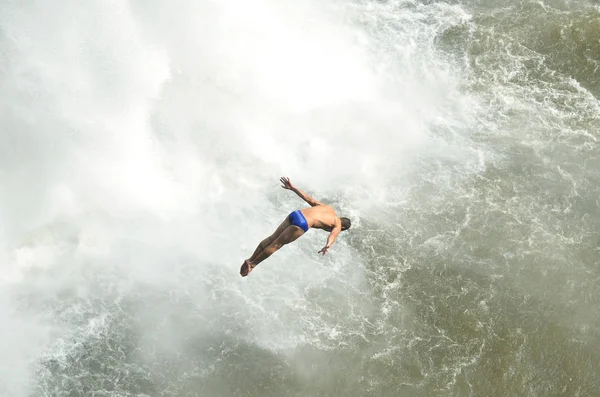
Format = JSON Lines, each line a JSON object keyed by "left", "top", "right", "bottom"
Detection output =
{"left": 240, "top": 177, "right": 350, "bottom": 277}
